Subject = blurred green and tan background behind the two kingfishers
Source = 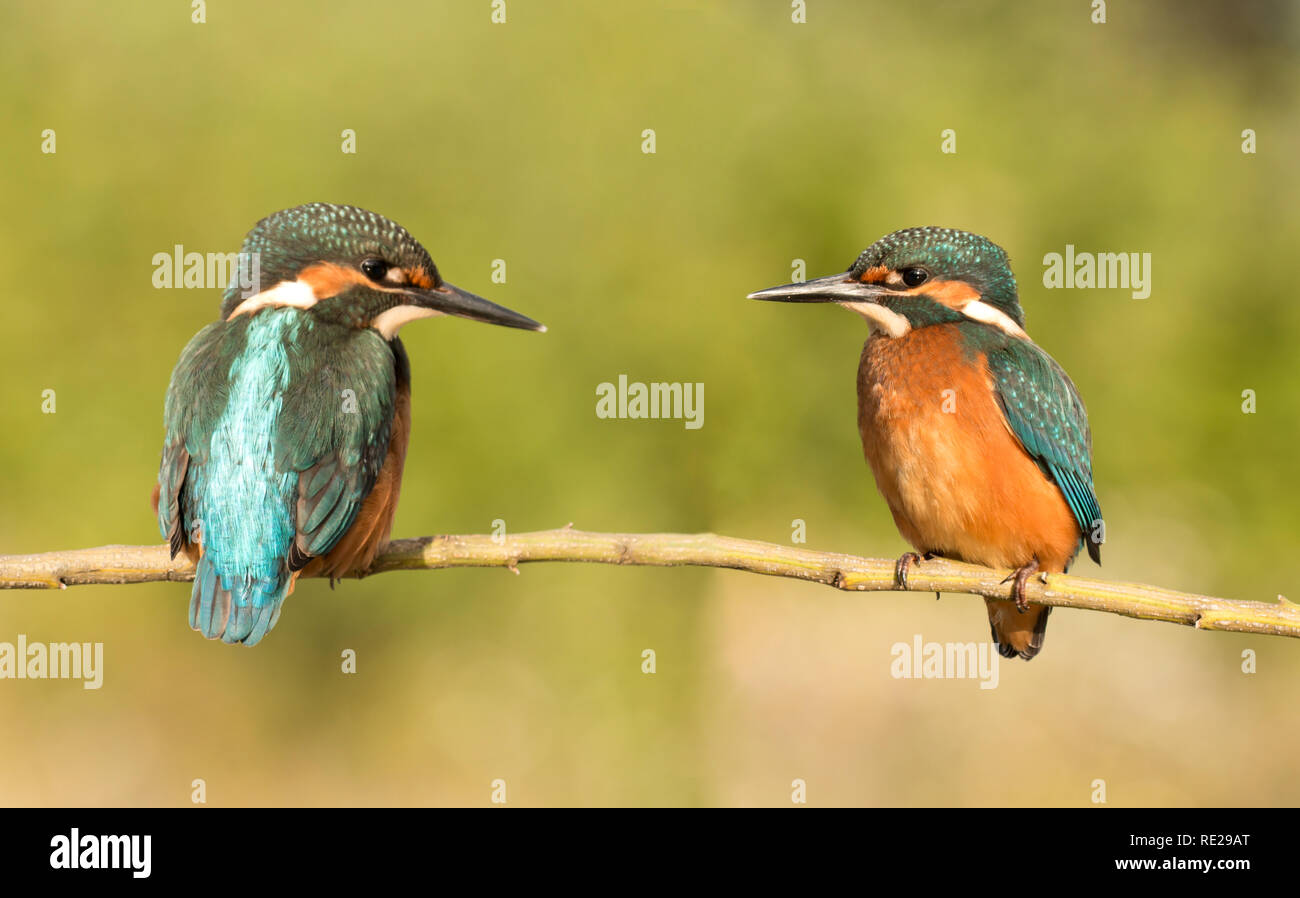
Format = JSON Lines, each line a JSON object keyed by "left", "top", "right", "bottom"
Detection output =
{"left": 0, "top": 0, "right": 1300, "bottom": 806}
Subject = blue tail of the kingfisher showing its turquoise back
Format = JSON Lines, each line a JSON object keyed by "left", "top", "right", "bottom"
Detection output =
{"left": 190, "top": 554, "right": 291, "bottom": 646}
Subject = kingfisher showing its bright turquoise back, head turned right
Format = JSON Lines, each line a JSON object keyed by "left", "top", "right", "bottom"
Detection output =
{"left": 153, "top": 203, "right": 546, "bottom": 646}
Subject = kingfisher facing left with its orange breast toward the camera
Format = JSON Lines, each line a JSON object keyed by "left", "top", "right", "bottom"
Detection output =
{"left": 749, "top": 227, "right": 1105, "bottom": 660}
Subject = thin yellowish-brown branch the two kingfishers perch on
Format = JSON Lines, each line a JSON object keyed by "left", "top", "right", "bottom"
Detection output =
{"left": 0, "top": 528, "right": 1300, "bottom": 637}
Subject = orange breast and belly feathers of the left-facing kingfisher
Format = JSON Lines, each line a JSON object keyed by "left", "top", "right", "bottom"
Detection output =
{"left": 858, "top": 325, "right": 1079, "bottom": 572}
